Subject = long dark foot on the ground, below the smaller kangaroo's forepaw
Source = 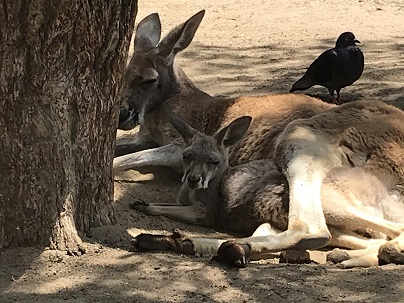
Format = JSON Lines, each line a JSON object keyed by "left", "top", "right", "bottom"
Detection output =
{"left": 130, "top": 229, "right": 183, "bottom": 251}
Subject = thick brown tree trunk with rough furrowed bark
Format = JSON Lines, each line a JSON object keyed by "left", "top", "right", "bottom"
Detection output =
{"left": 0, "top": 0, "right": 137, "bottom": 253}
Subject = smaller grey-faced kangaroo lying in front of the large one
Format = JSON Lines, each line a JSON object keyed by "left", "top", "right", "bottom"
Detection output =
{"left": 132, "top": 111, "right": 404, "bottom": 268}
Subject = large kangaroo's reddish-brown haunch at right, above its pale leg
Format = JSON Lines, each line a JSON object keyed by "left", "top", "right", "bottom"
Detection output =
{"left": 277, "top": 101, "right": 404, "bottom": 186}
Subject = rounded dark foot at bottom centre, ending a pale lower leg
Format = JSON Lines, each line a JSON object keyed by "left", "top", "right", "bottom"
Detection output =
{"left": 212, "top": 241, "right": 251, "bottom": 268}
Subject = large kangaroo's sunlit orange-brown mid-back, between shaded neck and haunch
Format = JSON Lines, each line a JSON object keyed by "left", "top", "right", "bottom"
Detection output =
{"left": 224, "top": 94, "right": 334, "bottom": 165}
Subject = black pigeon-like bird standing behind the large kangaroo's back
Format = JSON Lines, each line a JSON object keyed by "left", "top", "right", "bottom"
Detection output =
{"left": 290, "top": 32, "right": 364, "bottom": 104}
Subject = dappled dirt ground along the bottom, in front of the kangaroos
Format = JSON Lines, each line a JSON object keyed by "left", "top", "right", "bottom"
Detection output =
{"left": 0, "top": 247, "right": 404, "bottom": 303}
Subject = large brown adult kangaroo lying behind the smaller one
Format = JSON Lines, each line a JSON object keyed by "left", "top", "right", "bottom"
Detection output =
{"left": 114, "top": 11, "right": 404, "bottom": 266}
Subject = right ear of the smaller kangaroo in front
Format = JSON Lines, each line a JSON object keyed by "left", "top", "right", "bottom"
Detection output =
{"left": 214, "top": 116, "right": 252, "bottom": 147}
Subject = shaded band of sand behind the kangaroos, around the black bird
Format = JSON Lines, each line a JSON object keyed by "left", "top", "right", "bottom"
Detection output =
{"left": 181, "top": 36, "right": 404, "bottom": 108}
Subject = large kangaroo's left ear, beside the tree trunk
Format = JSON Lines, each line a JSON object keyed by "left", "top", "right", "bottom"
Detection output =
{"left": 135, "top": 13, "right": 161, "bottom": 51}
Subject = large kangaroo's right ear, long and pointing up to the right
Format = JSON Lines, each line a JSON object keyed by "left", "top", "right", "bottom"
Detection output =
{"left": 157, "top": 10, "right": 205, "bottom": 62}
